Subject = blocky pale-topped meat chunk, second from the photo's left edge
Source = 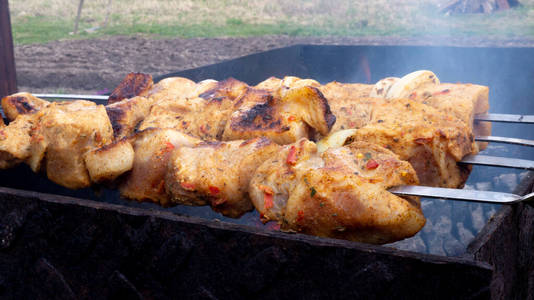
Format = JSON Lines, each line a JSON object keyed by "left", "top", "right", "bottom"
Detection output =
{"left": 30, "top": 101, "right": 113, "bottom": 189}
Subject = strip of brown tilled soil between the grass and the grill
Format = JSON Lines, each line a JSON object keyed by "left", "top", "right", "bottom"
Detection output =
{"left": 15, "top": 36, "right": 534, "bottom": 94}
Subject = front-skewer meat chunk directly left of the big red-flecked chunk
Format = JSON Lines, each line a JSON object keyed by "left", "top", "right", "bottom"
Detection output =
{"left": 165, "top": 137, "right": 280, "bottom": 218}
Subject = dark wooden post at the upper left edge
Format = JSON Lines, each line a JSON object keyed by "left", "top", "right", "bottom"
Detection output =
{"left": 0, "top": 0, "right": 17, "bottom": 98}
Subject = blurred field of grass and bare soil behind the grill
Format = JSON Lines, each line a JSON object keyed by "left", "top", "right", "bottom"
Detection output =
{"left": 9, "top": 0, "right": 534, "bottom": 94}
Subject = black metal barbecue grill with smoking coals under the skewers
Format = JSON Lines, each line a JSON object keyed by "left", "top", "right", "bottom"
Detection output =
{"left": 0, "top": 45, "right": 534, "bottom": 298}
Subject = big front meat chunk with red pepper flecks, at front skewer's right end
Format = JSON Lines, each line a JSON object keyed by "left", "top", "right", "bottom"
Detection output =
{"left": 249, "top": 140, "right": 425, "bottom": 244}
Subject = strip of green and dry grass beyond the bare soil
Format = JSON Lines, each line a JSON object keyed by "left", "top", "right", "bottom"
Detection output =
{"left": 10, "top": 0, "right": 534, "bottom": 44}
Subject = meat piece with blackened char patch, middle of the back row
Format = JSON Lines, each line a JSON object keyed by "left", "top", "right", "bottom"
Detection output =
{"left": 222, "top": 86, "right": 336, "bottom": 144}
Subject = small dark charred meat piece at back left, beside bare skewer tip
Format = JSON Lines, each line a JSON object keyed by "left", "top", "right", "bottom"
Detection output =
{"left": 108, "top": 73, "right": 154, "bottom": 105}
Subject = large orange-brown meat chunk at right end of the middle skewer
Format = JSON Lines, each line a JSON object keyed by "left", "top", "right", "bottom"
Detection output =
{"left": 324, "top": 98, "right": 478, "bottom": 188}
